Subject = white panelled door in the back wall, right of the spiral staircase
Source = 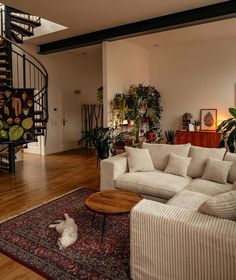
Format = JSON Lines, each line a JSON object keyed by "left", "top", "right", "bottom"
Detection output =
{"left": 61, "top": 91, "right": 82, "bottom": 151}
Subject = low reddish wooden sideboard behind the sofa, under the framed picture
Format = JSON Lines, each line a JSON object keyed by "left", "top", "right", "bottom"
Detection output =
{"left": 175, "top": 130, "right": 221, "bottom": 148}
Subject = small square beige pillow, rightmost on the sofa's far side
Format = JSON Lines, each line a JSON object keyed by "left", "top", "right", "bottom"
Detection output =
{"left": 202, "top": 158, "right": 232, "bottom": 184}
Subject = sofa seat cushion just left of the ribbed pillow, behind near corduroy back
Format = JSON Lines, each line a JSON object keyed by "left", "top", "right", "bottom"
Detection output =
{"left": 166, "top": 190, "right": 211, "bottom": 210}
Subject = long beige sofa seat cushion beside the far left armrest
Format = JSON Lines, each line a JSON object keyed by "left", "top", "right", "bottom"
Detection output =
{"left": 115, "top": 170, "right": 192, "bottom": 199}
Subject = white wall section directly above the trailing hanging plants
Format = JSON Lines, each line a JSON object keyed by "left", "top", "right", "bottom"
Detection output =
{"left": 103, "top": 40, "right": 149, "bottom": 125}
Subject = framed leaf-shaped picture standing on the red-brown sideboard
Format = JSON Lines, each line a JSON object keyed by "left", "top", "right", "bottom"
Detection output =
{"left": 201, "top": 109, "right": 217, "bottom": 131}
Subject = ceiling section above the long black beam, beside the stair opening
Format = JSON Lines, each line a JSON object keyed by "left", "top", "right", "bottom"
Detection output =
{"left": 1, "top": 0, "right": 224, "bottom": 44}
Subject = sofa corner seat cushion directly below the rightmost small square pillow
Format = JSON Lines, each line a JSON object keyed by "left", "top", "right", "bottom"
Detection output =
{"left": 185, "top": 179, "right": 233, "bottom": 196}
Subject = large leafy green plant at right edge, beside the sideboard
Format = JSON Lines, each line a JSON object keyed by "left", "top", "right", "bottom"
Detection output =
{"left": 217, "top": 108, "right": 236, "bottom": 153}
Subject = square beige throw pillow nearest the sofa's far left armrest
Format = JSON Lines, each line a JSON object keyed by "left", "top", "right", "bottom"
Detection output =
{"left": 125, "top": 147, "right": 155, "bottom": 172}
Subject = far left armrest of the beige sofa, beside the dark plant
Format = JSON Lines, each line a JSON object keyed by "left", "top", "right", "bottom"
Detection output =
{"left": 100, "top": 153, "right": 128, "bottom": 190}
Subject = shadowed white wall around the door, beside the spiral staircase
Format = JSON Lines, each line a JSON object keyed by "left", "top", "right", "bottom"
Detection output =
{"left": 24, "top": 44, "right": 102, "bottom": 154}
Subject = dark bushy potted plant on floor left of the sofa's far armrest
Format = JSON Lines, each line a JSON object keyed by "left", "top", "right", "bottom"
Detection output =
{"left": 79, "top": 127, "right": 115, "bottom": 159}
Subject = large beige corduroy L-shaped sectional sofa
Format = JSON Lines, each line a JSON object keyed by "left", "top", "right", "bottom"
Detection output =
{"left": 101, "top": 143, "right": 236, "bottom": 280}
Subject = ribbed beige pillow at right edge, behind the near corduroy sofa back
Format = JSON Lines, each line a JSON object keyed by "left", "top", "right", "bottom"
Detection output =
{"left": 198, "top": 191, "right": 236, "bottom": 220}
